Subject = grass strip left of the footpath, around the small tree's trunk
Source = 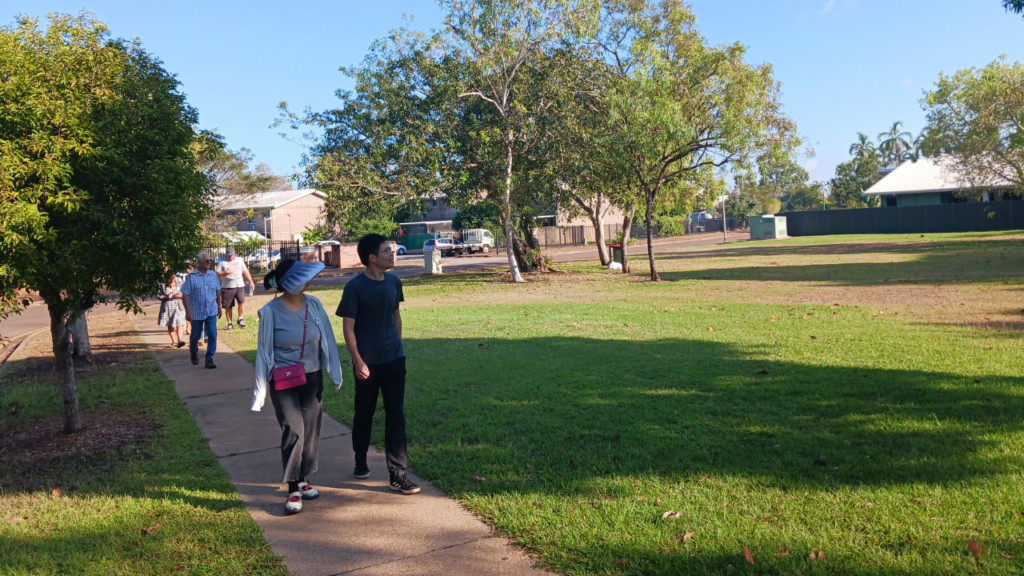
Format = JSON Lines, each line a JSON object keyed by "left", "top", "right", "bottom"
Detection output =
{"left": 0, "top": 314, "right": 287, "bottom": 576}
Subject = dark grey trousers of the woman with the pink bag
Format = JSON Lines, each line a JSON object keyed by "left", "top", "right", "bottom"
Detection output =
{"left": 269, "top": 371, "right": 324, "bottom": 482}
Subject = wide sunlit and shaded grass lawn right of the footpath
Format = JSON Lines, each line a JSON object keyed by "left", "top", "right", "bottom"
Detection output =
{"left": 224, "top": 230, "right": 1024, "bottom": 575}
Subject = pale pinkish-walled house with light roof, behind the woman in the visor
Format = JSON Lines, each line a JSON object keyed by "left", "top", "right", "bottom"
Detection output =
{"left": 219, "top": 189, "right": 325, "bottom": 241}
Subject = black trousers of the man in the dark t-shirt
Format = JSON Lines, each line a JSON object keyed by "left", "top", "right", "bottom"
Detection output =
{"left": 352, "top": 357, "right": 409, "bottom": 476}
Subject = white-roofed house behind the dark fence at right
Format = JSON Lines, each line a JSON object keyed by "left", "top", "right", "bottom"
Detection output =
{"left": 864, "top": 157, "right": 1010, "bottom": 206}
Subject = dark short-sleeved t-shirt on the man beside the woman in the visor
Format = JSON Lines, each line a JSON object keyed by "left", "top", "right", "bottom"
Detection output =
{"left": 335, "top": 273, "right": 406, "bottom": 364}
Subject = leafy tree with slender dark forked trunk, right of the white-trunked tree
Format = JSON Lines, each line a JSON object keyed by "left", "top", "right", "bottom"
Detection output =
{"left": 598, "top": 0, "right": 796, "bottom": 281}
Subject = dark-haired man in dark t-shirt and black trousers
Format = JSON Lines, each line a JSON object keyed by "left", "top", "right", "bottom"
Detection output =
{"left": 336, "top": 234, "right": 420, "bottom": 494}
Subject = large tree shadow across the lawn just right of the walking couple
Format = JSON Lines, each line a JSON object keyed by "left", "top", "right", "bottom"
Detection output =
{"left": 397, "top": 338, "right": 1024, "bottom": 493}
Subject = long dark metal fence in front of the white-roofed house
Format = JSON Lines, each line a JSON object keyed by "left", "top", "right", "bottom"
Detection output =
{"left": 778, "top": 200, "right": 1024, "bottom": 236}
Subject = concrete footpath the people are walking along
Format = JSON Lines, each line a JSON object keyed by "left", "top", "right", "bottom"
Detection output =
{"left": 136, "top": 315, "right": 550, "bottom": 576}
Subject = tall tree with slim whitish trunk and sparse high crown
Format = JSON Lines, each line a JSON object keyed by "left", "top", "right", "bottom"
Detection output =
{"left": 442, "top": 0, "right": 593, "bottom": 282}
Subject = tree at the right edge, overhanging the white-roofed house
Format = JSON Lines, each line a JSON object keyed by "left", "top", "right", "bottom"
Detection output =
{"left": 922, "top": 57, "right": 1024, "bottom": 191}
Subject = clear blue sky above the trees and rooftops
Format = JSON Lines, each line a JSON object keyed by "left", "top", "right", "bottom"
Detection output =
{"left": 9, "top": 0, "right": 1024, "bottom": 179}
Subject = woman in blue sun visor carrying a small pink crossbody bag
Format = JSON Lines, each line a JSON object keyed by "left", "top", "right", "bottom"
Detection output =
{"left": 251, "top": 259, "right": 341, "bottom": 513}
